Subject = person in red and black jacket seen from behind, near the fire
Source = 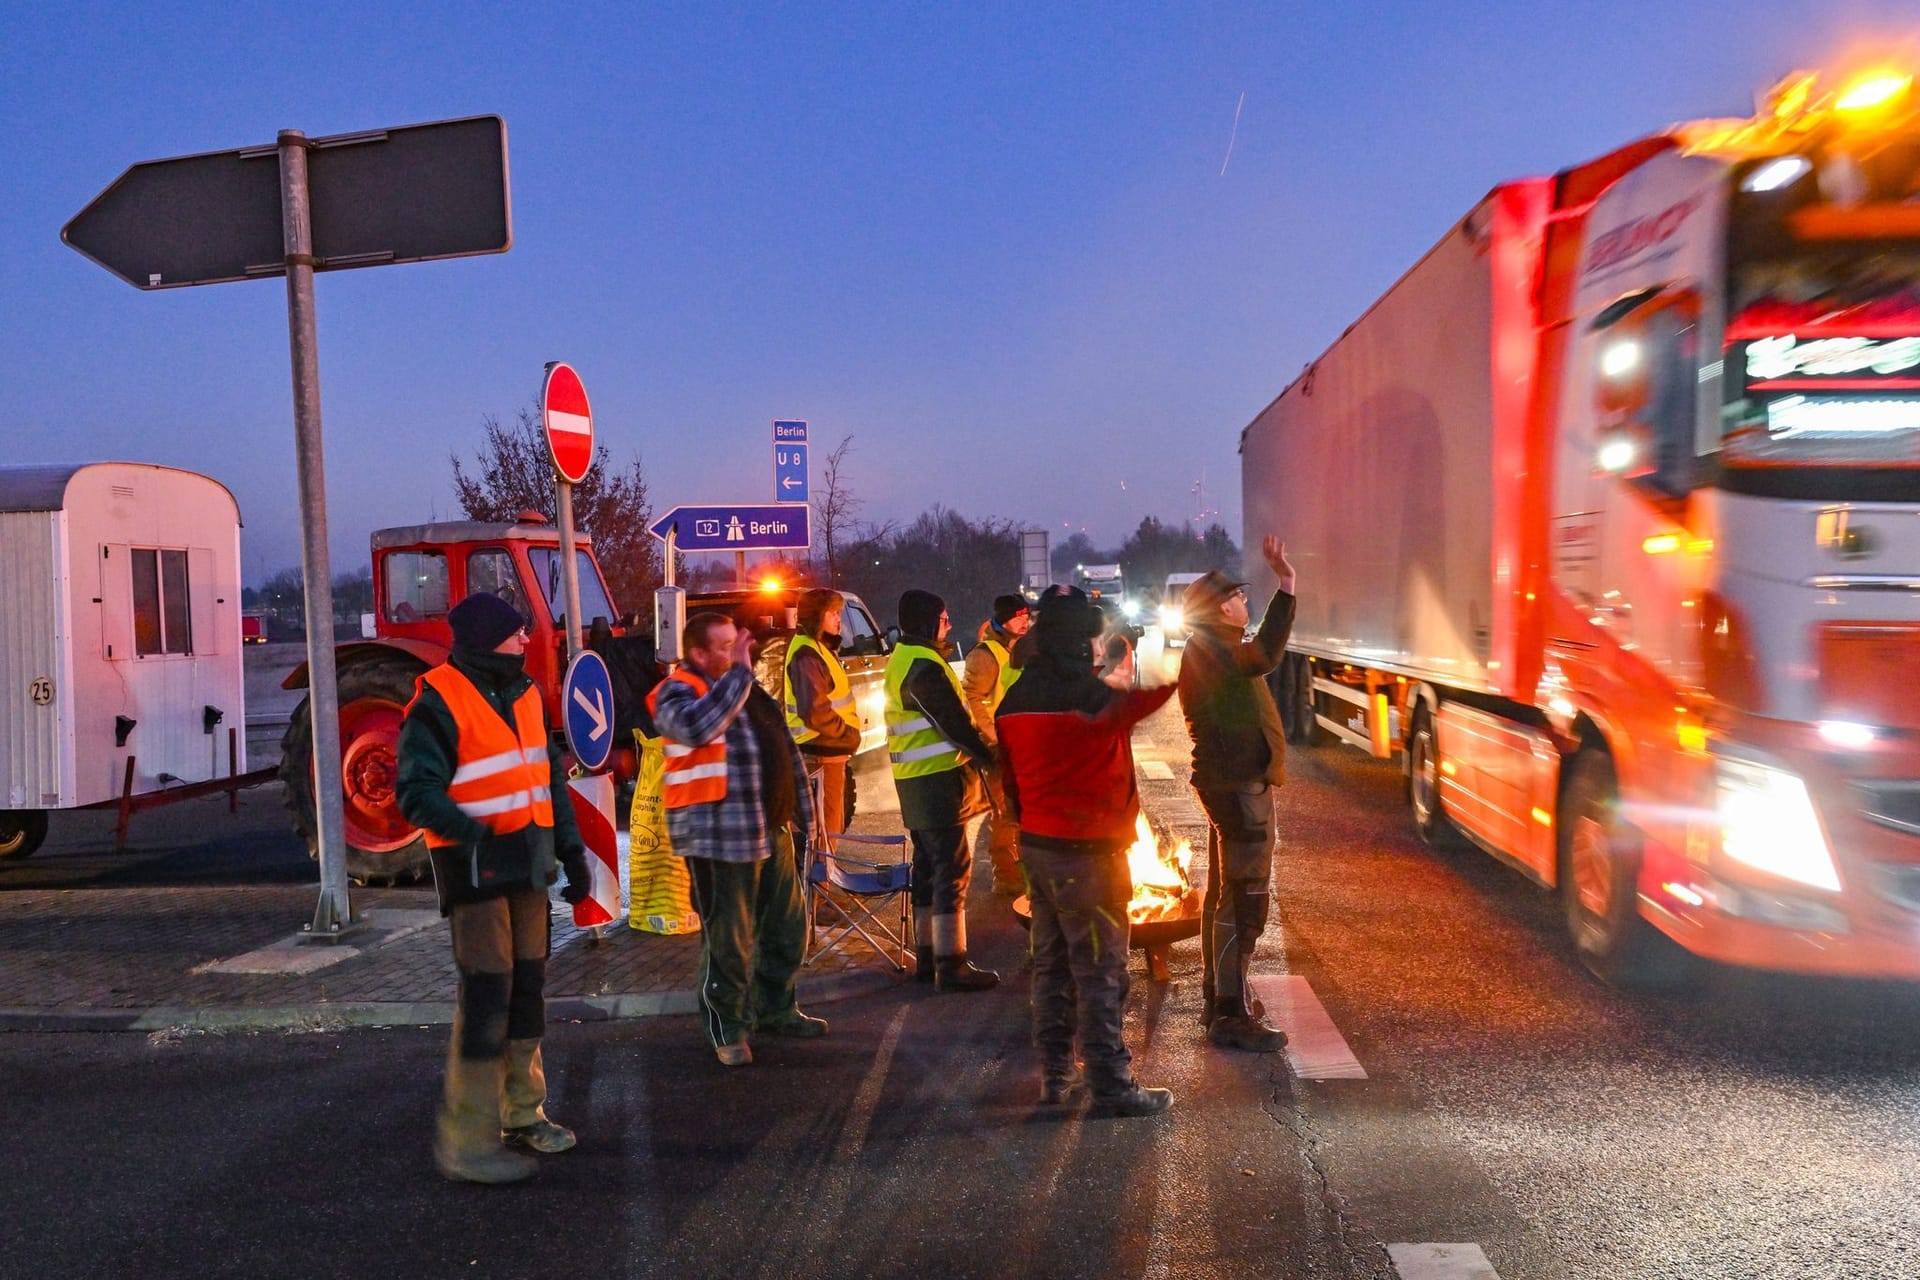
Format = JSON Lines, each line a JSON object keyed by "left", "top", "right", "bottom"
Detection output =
{"left": 995, "top": 591, "right": 1173, "bottom": 1115}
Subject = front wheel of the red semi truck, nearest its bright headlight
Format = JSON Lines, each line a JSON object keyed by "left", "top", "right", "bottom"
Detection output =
{"left": 1559, "top": 748, "right": 1688, "bottom": 986}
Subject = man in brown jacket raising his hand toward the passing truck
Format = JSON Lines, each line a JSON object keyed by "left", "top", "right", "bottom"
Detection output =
{"left": 1179, "top": 533, "right": 1294, "bottom": 1054}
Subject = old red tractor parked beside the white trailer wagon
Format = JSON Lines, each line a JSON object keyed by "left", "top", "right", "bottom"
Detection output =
{"left": 280, "top": 512, "right": 651, "bottom": 885}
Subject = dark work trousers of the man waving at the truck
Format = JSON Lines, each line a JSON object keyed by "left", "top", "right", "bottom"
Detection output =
{"left": 1200, "top": 783, "right": 1273, "bottom": 1006}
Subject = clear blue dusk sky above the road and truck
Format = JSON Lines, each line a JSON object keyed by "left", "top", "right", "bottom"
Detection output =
{"left": 0, "top": 0, "right": 1920, "bottom": 581}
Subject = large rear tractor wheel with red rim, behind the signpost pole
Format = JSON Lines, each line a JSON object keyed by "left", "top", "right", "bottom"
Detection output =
{"left": 280, "top": 654, "right": 430, "bottom": 885}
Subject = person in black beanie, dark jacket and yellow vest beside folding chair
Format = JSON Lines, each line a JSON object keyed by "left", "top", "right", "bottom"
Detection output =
{"left": 887, "top": 591, "right": 1000, "bottom": 990}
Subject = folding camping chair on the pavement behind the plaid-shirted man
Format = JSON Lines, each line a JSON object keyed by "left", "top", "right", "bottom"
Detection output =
{"left": 806, "top": 779, "right": 914, "bottom": 973}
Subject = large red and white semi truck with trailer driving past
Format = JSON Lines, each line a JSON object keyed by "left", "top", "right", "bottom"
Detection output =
{"left": 1240, "top": 73, "right": 1920, "bottom": 981}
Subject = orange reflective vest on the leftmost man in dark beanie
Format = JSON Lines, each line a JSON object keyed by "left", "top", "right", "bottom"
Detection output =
{"left": 407, "top": 666, "right": 553, "bottom": 848}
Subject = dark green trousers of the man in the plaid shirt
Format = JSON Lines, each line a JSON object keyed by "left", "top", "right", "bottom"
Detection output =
{"left": 687, "top": 829, "right": 806, "bottom": 1048}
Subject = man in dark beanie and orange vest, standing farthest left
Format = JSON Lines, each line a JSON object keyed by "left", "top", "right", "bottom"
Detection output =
{"left": 396, "top": 591, "right": 593, "bottom": 1182}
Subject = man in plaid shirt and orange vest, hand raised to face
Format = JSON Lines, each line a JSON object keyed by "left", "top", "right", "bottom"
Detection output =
{"left": 647, "top": 612, "right": 828, "bottom": 1067}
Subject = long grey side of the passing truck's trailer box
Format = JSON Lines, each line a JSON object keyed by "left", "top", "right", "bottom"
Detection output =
{"left": 1240, "top": 207, "right": 1501, "bottom": 689}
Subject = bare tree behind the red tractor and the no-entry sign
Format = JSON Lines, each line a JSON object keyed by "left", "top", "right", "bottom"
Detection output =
{"left": 453, "top": 403, "right": 662, "bottom": 618}
